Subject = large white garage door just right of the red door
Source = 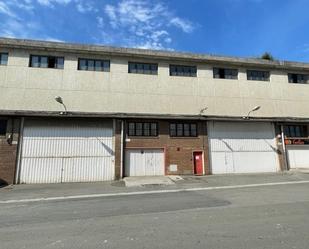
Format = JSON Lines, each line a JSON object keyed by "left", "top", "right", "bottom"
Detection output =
{"left": 208, "top": 122, "right": 279, "bottom": 174}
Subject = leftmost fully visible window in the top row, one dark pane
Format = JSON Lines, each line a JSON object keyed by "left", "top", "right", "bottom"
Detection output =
{"left": 29, "top": 55, "right": 64, "bottom": 69}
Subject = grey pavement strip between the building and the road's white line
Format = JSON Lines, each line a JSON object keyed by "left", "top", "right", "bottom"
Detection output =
{"left": 0, "top": 172, "right": 309, "bottom": 201}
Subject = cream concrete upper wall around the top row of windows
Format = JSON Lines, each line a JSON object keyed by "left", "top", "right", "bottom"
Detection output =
{"left": 0, "top": 48, "right": 309, "bottom": 118}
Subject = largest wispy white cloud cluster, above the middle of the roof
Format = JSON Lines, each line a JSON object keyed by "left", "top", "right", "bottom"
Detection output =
{"left": 103, "top": 0, "right": 194, "bottom": 49}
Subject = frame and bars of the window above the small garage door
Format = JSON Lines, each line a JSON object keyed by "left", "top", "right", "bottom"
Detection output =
{"left": 127, "top": 121, "right": 159, "bottom": 138}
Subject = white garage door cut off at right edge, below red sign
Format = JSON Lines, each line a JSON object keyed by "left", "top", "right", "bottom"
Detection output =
{"left": 287, "top": 145, "right": 309, "bottom": 169}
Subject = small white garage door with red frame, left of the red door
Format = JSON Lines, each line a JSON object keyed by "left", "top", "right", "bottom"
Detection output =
{"left": 125, "top": 149, "right": 164, "bottom": 176}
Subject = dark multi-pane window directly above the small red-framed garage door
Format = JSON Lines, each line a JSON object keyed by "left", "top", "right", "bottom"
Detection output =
{"left": 128, "top": 122, "right": 158, "bottom": 137}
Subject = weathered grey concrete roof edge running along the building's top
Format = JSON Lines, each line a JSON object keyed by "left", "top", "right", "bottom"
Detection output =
{"left": 0, "top": 37, "right": 309, "bottom": 70}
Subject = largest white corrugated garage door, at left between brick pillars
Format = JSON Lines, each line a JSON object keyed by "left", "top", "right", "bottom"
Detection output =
{"left": 19, "top": 120, "right": 115, "bottom": 183}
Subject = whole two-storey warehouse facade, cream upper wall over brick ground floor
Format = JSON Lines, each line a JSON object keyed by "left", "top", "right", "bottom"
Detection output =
{"left": 0, "top": 38, "right": 309, "bottom": 183}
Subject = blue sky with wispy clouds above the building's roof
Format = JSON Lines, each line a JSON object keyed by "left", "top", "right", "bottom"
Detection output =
{"left": 0, "top": 0, "right": 309, "bottom": 62}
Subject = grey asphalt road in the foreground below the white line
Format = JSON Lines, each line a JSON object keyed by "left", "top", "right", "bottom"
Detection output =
{"left": 0, "top": 184, "right": 309, "bottom": 249}
